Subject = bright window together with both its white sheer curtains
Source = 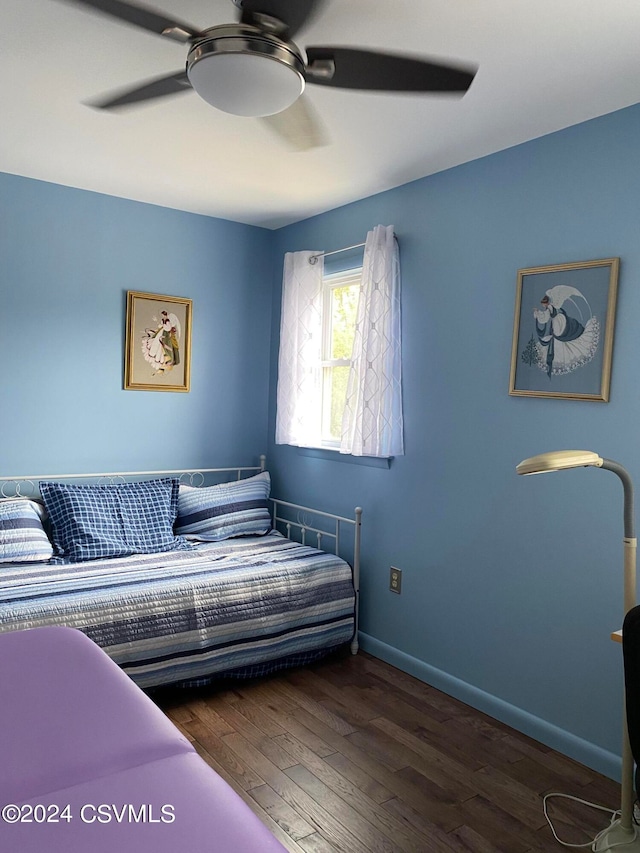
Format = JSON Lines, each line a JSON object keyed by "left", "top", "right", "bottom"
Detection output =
{"left": 276, "top": 225, "right": 404, "bottom": 458}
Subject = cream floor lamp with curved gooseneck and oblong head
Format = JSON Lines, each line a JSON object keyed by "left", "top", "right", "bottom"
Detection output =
{"left": 516, "top": 450, "right": 640, "bottom": 853}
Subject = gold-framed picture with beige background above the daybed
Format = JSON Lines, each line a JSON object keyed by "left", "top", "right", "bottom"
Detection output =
{"left": 124, "top": 290, "right": 192, "bottom": 391}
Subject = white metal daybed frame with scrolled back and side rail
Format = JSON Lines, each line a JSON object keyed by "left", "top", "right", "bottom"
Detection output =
{"left": 0, "top": 454, "right": 362, "bottom": 655}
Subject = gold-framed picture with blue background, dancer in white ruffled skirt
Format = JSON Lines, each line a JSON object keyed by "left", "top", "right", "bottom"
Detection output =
{"left": 509, "top": 258, "right": 620, "bottom": 403}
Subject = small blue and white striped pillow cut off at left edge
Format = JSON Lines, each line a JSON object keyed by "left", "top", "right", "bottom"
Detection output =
{"left": 0, "top": 498, "right": 53, "bottom": 563}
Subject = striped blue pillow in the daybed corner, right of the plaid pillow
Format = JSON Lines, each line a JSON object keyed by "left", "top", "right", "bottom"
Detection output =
{"left": 175, "top": 471, "right": 271, "bottom": 542}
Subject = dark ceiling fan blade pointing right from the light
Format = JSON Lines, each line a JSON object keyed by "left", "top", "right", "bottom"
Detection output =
{"left": 306, "top": 47, "right": 477, "bottom": 92}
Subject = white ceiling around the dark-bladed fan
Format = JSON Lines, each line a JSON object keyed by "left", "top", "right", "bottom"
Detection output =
{"left": 0, "top": 0, "right": 640, "bottom": 228}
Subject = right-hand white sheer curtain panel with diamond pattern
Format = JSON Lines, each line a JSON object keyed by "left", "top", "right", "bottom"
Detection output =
{"left": 340, "top": 225, "right": 404, "bottom": 456}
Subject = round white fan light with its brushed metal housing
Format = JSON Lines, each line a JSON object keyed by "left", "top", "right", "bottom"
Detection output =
{"left": 187, "top": 27, "right": 305, "bottom": 116}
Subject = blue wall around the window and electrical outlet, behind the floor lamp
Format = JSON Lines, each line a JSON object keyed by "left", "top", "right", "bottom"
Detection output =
{"left": 269, "top": 106, "right": 640, "bottom": 773}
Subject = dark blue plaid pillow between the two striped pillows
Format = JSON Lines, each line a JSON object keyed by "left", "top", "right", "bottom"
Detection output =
{"left": 40, "top": 479, "right": 191, "bottom": 563}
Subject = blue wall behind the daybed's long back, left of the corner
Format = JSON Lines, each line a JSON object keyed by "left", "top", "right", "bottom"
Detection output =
{"left": 0, "top": 174, "right": 272, "bottom": 475}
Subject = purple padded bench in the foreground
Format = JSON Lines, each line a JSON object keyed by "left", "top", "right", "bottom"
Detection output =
{"left": 0, "top": 627, "right": 285, "bottom": 853}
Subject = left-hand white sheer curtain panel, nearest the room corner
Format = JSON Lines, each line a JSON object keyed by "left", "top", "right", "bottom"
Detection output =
{"left": 276, "top": 252, "right": 324, "bottom": 447}
